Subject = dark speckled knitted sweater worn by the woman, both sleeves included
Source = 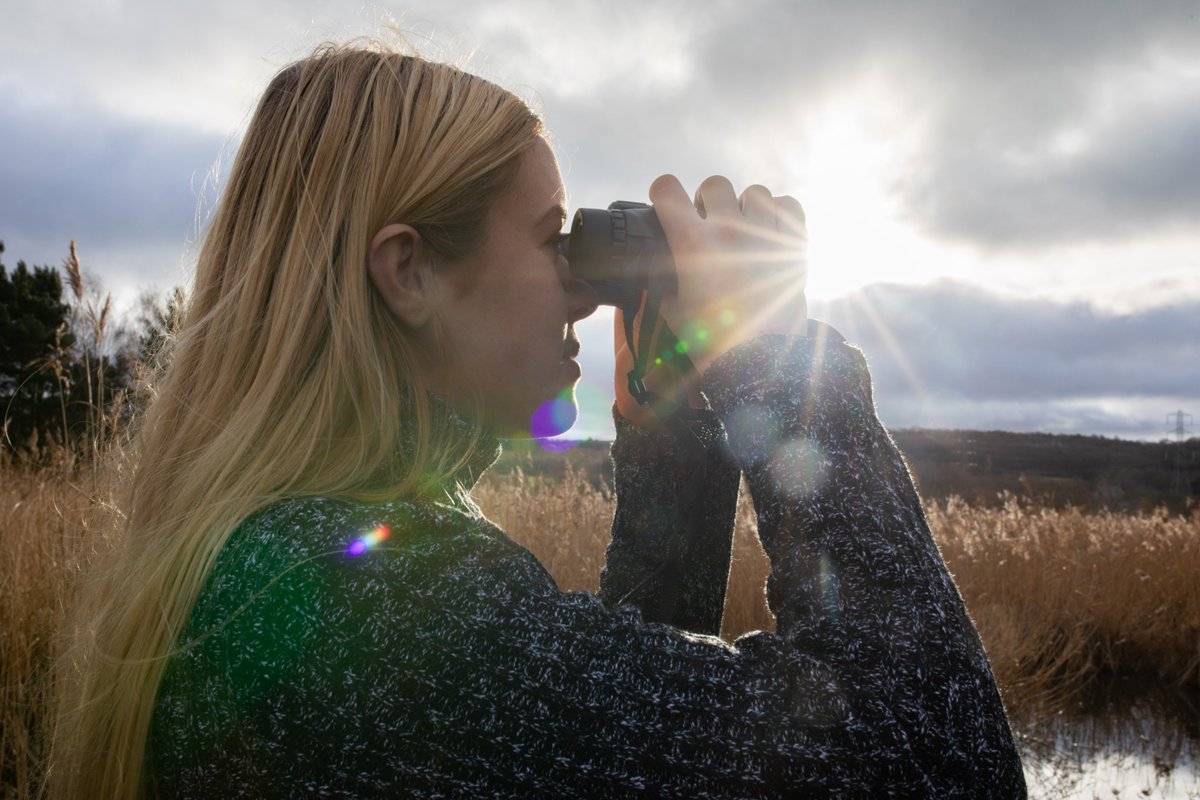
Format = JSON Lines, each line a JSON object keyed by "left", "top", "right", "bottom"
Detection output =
{"left": 149, "top": 337, "right": 1025, "bottom": 798}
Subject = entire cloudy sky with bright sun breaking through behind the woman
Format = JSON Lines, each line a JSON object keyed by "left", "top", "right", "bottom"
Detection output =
{"left": 0, "top": 0, "right": 1200, "bottom": 439}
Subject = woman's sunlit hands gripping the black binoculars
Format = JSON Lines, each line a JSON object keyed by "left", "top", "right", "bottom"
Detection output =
{"left": 614, "top": 175, "right": 808, "bottom": 427}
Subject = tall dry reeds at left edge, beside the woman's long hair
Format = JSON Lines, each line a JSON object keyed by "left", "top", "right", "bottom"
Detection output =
{"left": 0, "top": 240, "right": 131, "bottom": 798}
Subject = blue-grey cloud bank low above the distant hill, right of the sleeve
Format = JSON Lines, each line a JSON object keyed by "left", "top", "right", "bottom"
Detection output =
{"left": 812, "top": 282, "right": 1200, "bottom": 433}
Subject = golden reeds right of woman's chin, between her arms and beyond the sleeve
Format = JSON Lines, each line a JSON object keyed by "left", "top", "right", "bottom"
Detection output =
{"left": 475, "top": 471, "right": 1200, "bottom": 714}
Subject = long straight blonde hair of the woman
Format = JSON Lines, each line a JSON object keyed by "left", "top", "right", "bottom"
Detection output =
{"left": 47, "top": 44, "right": 544, "bottom": 798}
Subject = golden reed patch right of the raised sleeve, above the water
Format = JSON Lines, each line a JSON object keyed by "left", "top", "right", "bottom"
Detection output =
{"left": 926, "top": 495, "right": 1200, "bottom": 711}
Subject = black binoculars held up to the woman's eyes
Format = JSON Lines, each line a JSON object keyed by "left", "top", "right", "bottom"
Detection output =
{"left": 559, "top": 200, "right": 676, "bottom": 315}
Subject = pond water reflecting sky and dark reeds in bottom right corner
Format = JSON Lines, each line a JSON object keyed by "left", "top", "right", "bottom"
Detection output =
{"left": 1014, "top": 680, "right": 1200, "bottom": 800}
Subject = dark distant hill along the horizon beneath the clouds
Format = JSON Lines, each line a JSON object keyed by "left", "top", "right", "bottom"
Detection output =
{"left": 493, "top": 429, "right": 1200, "bottom": 511}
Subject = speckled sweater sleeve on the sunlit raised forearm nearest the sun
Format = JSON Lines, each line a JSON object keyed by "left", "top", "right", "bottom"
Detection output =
{"left": 706, "top": 337, "right": 1025, "bottom": 798}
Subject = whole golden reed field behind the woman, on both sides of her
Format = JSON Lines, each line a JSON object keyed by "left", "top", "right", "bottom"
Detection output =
{"left": 0, "top": 448, "right": 1200, "bottom": 798}
